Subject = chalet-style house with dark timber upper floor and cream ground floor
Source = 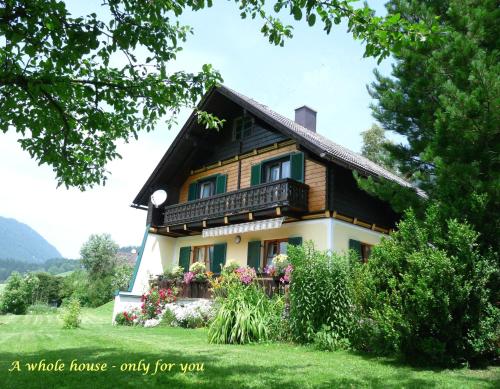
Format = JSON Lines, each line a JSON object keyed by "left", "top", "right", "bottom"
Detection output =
{"left": 115, "top": 86, "right": 409, "bottom": 311}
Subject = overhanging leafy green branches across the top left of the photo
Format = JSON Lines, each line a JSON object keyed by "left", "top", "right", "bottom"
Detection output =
{"left": 0, "top": 0, "right": 430, "bottom": 190}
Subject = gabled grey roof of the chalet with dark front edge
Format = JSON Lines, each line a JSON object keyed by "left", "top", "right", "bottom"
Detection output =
{"left": 134, "top": 85, "right": 425, "bottom": 205}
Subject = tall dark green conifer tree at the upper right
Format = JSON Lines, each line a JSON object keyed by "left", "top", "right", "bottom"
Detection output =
{"left": 365, "top": 0, "right": 500, "bottom": 251}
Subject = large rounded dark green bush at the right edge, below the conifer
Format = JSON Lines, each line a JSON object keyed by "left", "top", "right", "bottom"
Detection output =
{"left": 355, "top": 207, "right": 500, "bottom": 364}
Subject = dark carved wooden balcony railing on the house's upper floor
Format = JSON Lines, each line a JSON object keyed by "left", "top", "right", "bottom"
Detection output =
{"left": 164, "top": 178, "right": 309, "bottom": 225}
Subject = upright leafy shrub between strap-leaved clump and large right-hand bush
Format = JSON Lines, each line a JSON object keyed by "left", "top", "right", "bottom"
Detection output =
{"left": 288, "top": 242, "right": 353, "bottom": 343}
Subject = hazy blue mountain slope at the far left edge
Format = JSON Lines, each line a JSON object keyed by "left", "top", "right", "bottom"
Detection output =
{"left": 0, "top": 216, "right": 62, "bottom": 263}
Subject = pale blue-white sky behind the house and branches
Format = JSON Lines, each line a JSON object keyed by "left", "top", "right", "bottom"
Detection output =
{"left": 0, "top": 0, "right": 391, "bottom": 258}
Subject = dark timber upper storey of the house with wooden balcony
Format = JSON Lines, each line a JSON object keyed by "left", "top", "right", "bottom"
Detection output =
{"left": 134, "top": 88, "right": 404, "bottom": 236}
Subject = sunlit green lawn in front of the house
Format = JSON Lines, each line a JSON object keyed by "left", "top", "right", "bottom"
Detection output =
{"left": 0, "top": 304, "right": 500, "bottom": 389}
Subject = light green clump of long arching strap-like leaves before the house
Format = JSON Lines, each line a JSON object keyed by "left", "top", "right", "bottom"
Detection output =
{"left": 208, "top": 273, "right": 281, "bottom": 344}
